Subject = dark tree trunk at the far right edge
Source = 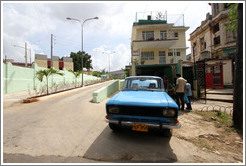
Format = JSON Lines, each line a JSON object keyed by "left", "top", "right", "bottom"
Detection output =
{"left": 233, "top": 3, "right": 243, "bottom": 129}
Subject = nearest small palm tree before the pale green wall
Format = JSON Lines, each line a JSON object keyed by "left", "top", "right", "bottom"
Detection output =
{"left": 36, "top": 68, "right": 64, "bottom": 95}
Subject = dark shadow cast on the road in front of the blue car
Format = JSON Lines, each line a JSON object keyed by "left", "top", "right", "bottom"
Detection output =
{"left": 84, "top": 127, "right": 177, "bottom": 163}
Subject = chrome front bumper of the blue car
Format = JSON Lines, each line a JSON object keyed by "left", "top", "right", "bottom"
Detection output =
{"left": 105, "top": 118, "right": 181, "bottom": 129}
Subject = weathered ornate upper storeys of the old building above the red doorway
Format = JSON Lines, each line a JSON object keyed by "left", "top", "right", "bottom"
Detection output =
{"left": 189, "top": 3, "right": 236, "bottom": 61}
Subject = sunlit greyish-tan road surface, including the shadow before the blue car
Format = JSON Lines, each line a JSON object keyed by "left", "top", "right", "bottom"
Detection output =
{"left": 3, "top": 83, "right": 182, "bottom": 163}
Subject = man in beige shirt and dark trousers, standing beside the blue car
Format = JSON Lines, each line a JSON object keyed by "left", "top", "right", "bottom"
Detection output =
{"left": 174, "top": 74, "right": 187, "bottom": 111}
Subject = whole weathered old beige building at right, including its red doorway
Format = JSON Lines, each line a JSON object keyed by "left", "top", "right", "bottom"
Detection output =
{"left": 189, "top": 3, "right": 237, "bottom": 88}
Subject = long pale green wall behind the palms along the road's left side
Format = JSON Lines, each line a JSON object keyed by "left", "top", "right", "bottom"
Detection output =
{"left": 3, "top": 62, "right": 101, "bottom": 94}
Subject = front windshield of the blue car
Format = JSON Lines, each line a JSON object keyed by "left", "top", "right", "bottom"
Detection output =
{"left": 123, "top": 77, "right": 164, "bottom": 91}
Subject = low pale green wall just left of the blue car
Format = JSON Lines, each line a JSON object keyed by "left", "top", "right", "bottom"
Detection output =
{"left": 93, "top": 80, "right": 124, "bottom": 103}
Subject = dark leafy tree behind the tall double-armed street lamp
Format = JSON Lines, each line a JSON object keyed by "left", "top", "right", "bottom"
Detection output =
{"left": 70, "top": 51, "right": 93, "bottom": 71}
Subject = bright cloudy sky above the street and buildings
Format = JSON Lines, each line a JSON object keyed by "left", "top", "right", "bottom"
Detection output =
{"left": 1, "top": 1, "right": 211, "bottom": 71}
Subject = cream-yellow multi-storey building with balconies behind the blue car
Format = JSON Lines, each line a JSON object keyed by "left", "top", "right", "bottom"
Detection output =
{"left": 131, "top": 12, "right": 189, "bottom": 75}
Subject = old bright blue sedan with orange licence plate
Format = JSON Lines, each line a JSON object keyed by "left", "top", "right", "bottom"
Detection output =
{"left": 105, "top": 76, "right": 181, "bottom": 136}
